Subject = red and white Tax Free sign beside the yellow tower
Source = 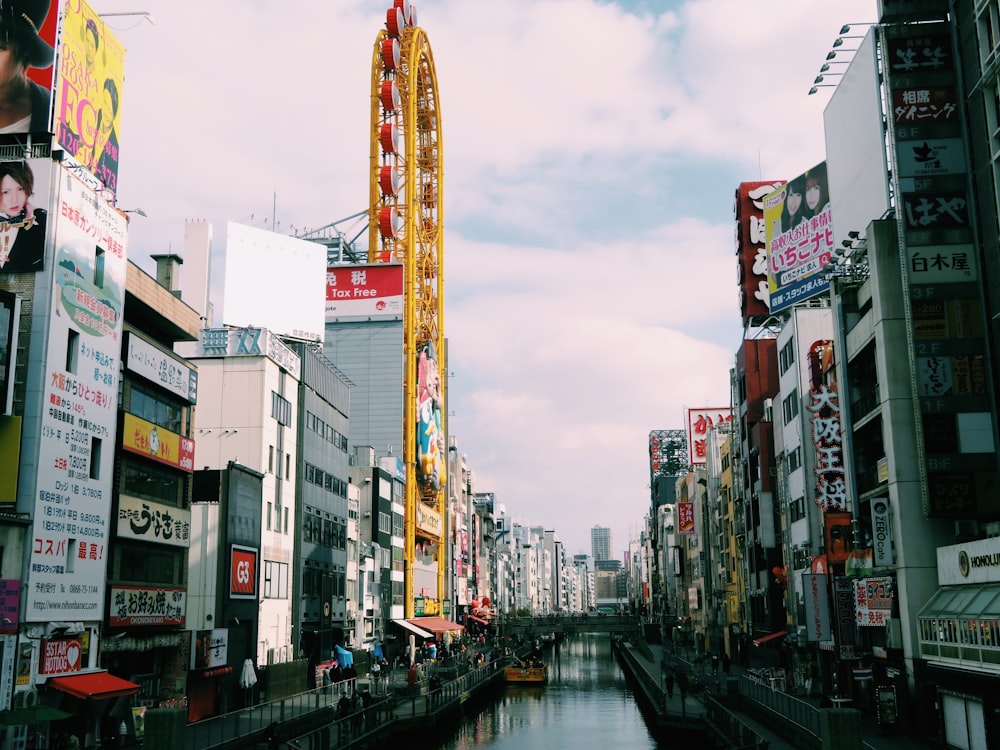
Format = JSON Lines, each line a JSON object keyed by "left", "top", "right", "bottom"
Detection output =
{"left": 326, "top": 263, "right": 403, "bottom": 320}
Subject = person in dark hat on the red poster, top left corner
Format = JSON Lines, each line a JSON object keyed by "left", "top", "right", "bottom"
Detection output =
{"left": 0, "top": 0, "right": 54, "bottom": 133}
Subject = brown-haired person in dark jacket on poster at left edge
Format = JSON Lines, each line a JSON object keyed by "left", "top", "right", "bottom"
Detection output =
{"left": 0, "top": 161, "right": 47, "bottom": 273}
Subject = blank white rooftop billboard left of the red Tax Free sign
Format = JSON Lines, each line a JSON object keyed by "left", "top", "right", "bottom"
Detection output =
{"left": 223, "top": 221, "right": 326, "bottom": 340}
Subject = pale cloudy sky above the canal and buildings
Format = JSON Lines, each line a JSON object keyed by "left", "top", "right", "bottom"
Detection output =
{"left": 91, "top": 0, "right": 876, "bottom": 554}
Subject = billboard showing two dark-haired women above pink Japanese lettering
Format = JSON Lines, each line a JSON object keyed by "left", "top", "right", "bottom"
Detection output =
{"left": 764, "top": 162, "right": 834, "bottom": 312}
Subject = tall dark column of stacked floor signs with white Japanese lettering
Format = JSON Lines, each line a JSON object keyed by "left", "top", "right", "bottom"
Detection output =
{"left": 880, "top": 23, "right": 1000, "bottom": 516}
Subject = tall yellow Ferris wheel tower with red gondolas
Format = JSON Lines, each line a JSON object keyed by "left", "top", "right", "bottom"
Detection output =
{"left": 368, "top": 0, "right": 448, "bottom": 617}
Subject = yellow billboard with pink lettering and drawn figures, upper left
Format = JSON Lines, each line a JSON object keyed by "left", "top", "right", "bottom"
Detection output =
{"left": 54, "top": 0, "right": 125, "bottom": 193}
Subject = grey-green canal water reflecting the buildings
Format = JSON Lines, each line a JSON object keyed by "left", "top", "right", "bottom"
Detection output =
{"left": 437, "top": 634, "right": 664, "bottom": 750}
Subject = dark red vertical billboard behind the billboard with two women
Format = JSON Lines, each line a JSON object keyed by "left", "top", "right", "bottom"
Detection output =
{"left": 735, "top": 181, "right": 784, "bottom": 324}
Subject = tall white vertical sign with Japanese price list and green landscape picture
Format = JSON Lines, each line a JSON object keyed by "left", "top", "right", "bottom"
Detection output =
{"left": 25, "top": 166, "right": 127, "bottom": 622}
